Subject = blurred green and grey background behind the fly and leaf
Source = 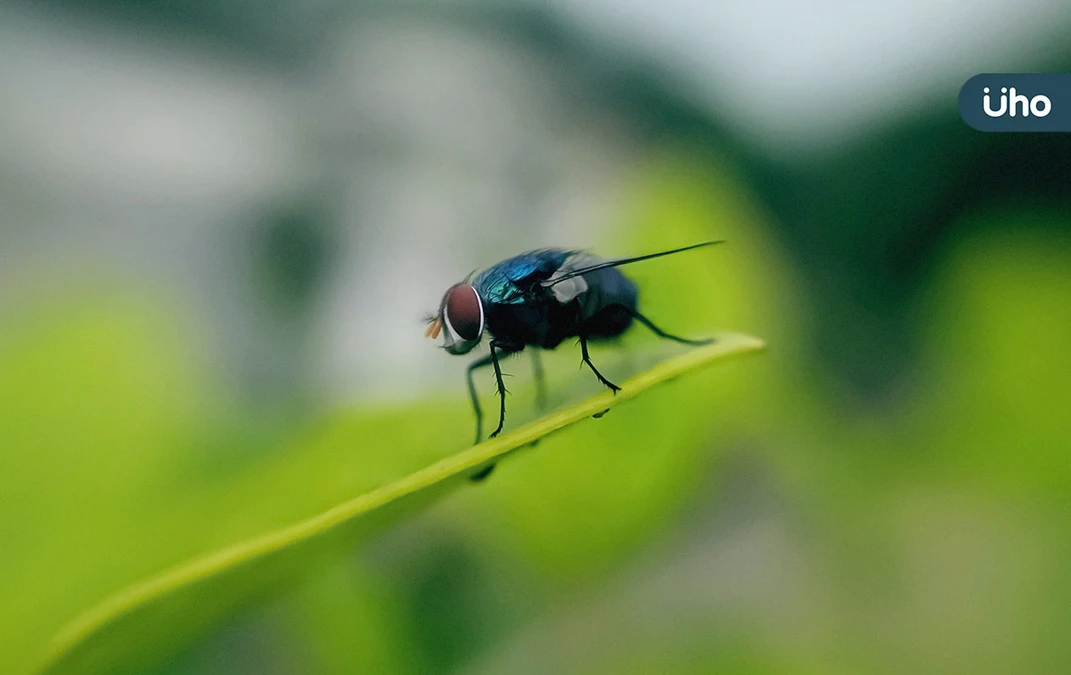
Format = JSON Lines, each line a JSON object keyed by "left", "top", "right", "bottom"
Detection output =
{"left": 6, "top": 0, "right": 1071, "bottom": 675}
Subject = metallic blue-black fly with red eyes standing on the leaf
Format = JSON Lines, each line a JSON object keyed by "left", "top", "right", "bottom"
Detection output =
{"left": 424, "top": 241, "right": 722, "bottom": 480}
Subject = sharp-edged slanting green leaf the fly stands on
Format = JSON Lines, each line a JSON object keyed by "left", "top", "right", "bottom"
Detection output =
{"left": 35, "top": 333, "right": 765, "bottom": 675}
